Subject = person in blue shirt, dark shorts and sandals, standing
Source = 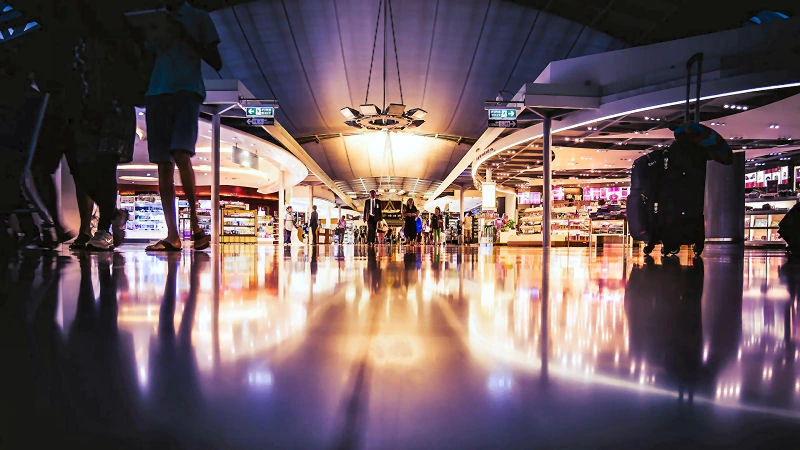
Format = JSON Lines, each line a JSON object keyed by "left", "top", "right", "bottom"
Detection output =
{"left": 145, "top": 0, "right": 222, "bottom": 251}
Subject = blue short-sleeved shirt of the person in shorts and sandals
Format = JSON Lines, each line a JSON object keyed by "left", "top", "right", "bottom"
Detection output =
{"left": 146, "top": 2, "right": 219, "bottom": 98}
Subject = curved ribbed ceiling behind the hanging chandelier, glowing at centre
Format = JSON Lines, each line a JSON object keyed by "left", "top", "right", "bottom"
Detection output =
{"left": 206, "top": 0, "right": 624, "bottom": 184}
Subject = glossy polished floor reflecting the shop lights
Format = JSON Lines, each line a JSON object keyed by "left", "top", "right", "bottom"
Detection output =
{"left": 0, "top": 245, "right": 800, "bottom": 449}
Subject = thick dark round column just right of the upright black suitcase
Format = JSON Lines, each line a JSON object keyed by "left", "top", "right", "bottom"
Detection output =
{"left": 705, "top": 152, "right": 745, "bottom": 244}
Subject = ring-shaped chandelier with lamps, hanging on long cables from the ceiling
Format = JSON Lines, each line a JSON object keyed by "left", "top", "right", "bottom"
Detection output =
{"left": 340, "top": 0, "right": 428, "bottom": 131}
